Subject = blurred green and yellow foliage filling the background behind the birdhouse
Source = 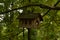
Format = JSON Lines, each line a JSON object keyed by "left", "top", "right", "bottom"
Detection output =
{"left": 0, "top": 0, "right": 60, "bottom": 40}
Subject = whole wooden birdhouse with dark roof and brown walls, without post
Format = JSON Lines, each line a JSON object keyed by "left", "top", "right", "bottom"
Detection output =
{"left": 18, "top": 13, "right": 42, "bottom": 28}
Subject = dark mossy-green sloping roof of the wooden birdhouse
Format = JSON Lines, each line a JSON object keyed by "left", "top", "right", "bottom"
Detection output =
{"left": 18, "top": 13, "right": 42, "bottom": 19}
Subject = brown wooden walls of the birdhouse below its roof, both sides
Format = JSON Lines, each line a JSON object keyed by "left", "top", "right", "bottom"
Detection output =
{"left": 20, "top": 18, "right": 40, "bottom": 28}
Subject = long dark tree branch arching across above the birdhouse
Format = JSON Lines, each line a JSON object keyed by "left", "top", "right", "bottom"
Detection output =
{"left": 0, "top": 4, "right": 60, "bottom": 14}
